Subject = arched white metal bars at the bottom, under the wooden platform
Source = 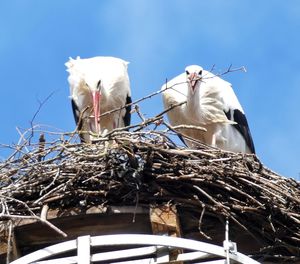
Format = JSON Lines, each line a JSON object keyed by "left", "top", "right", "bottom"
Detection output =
{"left": 11, "top": 234, "right": 259, "bottom": 264}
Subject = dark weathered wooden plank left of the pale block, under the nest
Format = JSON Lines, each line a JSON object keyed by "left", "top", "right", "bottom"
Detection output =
{"left": 16, "top": 213, "right": 151, "bottom": 248}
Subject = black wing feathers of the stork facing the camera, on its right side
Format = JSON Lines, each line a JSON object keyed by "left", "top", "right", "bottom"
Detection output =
{"left": 224, "top": 109, "right": 255, "bottom": 154}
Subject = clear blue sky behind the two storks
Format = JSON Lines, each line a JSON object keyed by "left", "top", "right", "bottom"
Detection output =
{"left": 0, "top": 0, "right": 300, "bottom": 180}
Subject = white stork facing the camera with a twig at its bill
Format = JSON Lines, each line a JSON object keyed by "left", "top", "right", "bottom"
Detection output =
{"left": 162, "top": 65, "right": 255, "bottom": 153}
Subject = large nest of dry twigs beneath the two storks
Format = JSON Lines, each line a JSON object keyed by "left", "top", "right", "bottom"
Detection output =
{"left": 0, "top": 117, "right": 300, "bottom": 258}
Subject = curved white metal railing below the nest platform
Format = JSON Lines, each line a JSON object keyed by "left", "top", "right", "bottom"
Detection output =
{"left": 11, "top": 234, "right": 259, "bottom": 264}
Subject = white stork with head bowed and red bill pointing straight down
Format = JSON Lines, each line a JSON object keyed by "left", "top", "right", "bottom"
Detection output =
{"left": 65, "top": 57, "right": 131, "bottom": 142}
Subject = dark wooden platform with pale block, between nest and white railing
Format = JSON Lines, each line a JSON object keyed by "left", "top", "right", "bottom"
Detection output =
{"left": 0, "top": 205, "right": 259, "bottom": 263}
